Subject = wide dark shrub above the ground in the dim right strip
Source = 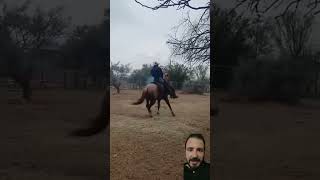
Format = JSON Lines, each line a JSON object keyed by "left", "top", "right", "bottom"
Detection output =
{"left": 230, "top": 56, "right": 312, "bottom": 103}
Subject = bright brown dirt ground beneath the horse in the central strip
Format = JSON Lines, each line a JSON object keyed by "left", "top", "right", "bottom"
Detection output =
{"left": 110, "top": 90, "right": 210, "bottom": 180}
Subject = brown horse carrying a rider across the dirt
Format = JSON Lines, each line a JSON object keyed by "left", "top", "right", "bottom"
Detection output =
{"left": 132, "top": 83, "right": 178, "bottom": 117}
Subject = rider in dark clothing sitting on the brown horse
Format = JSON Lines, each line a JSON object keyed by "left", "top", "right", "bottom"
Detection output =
{"left": 151, "top": 62, "right": 177, "bottom": 98}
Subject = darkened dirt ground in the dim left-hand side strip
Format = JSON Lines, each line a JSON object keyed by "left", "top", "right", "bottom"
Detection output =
{"left": 0, "top": 90, "right": 108, "bottom": 180}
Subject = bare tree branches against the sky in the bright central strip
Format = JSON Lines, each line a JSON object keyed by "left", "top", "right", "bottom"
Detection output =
{"left": 135, "top": 0, "right": 210, "bottom": 65}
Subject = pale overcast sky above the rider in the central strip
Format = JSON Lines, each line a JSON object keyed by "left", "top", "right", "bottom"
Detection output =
{"left": 110, "top": 0, "right": 209, "bottom": 69}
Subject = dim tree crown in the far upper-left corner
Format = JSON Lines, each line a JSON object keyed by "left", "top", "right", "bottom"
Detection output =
{"left": 1, "top": 1, "right": 70, "bottom": 50}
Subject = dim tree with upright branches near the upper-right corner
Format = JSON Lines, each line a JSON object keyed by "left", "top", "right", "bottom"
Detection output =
{"left": 274, "top": 11, "right": 314, "bottom": 57}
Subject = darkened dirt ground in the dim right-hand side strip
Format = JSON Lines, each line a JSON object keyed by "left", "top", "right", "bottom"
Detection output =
{"left": 211, "top": 94, "right": 320, "bottom": 180}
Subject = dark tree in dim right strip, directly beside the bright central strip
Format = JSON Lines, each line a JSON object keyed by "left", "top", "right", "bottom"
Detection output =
{"left": 214, "top": 6, "right": 255, "bottom": 88}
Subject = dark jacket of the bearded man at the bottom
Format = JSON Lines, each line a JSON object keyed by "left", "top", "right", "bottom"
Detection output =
{"left": 183, "top": 161, "right": 210, "bottom": 180}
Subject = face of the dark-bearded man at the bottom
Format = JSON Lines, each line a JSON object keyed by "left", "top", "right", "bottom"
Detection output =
{"left": 186, "top": 138, "right": 204, "bottom": 169}
